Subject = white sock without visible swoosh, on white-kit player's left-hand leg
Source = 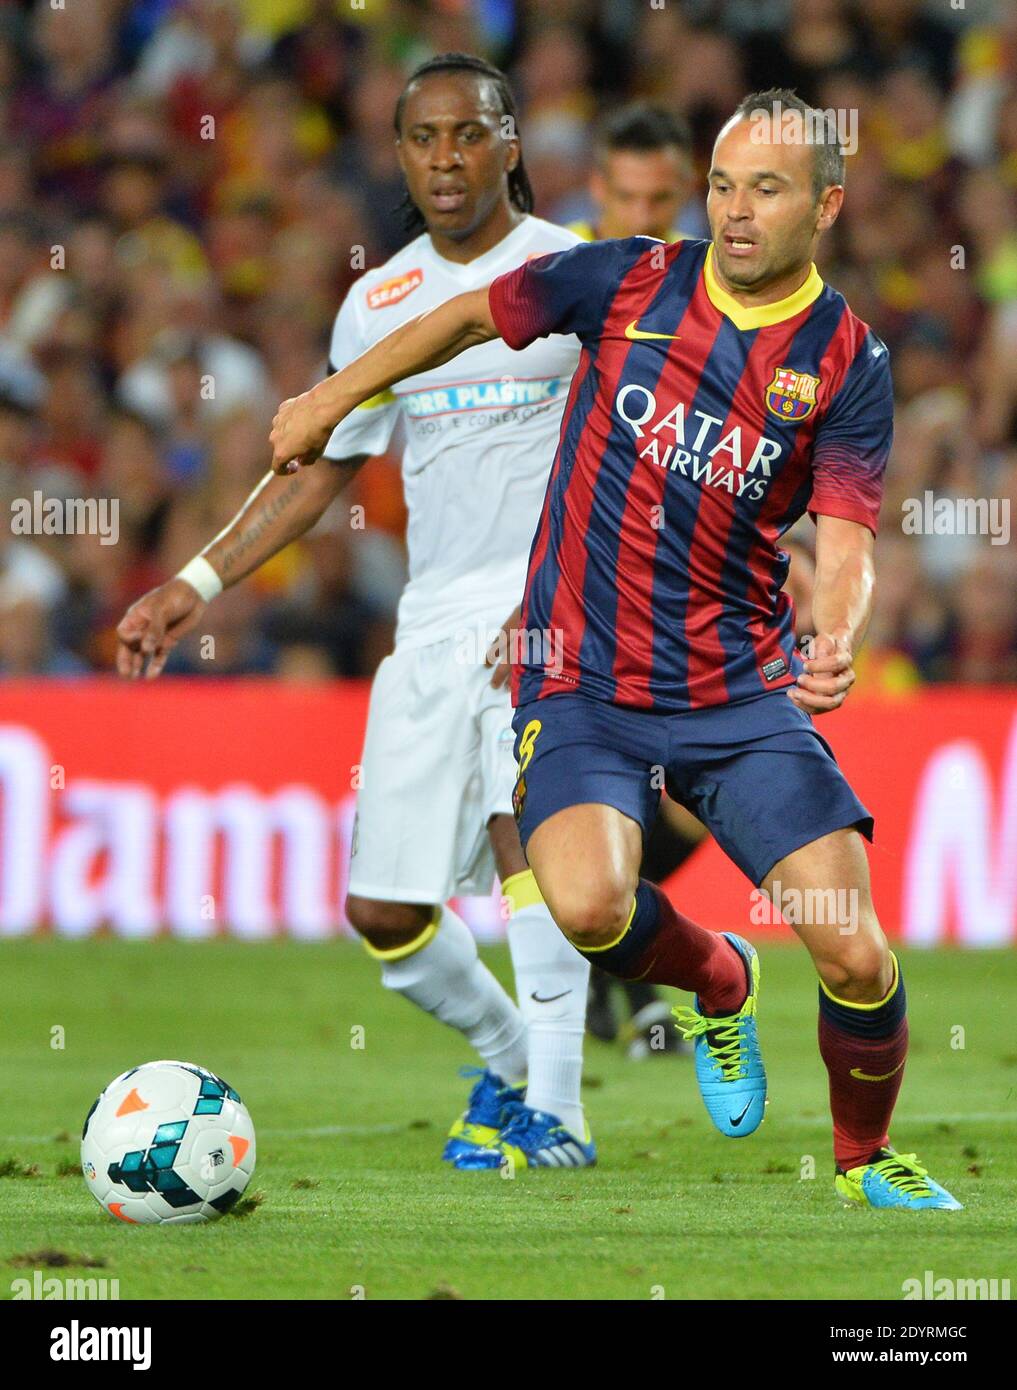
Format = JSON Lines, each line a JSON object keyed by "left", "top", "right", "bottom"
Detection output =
{"left": 371, "top": 908, "right": 527, "bottom": 1086}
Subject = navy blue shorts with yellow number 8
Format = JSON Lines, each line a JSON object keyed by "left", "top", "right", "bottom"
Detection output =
{"left": 513, "top": 689, "right": 873, "bottom": 884}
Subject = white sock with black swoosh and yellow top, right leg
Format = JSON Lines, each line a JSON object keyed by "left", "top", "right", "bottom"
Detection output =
{"left": 503, "top": 874, "right": 589, "bottom": 1138}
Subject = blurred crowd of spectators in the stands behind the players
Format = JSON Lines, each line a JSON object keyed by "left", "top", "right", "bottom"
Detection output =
{"left": 0, "top": 0, "right": 1017, "bottom": 689}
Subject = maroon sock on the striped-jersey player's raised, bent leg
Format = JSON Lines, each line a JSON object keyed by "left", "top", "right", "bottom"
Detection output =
{"left": 589, "top": 878, "right": 749, "bottom": 1016}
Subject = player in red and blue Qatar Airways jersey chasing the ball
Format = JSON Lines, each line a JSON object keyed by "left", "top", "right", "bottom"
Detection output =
{"left": 272, "top": 90, "right": 960, "bottom": 1209}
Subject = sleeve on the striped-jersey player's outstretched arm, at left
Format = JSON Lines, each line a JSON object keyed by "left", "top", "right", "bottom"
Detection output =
{"left": 488, "top": 236, "right": 639, "bottom": 350}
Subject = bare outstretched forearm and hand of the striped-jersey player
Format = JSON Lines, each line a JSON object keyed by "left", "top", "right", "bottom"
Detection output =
{"left": 270, "top": 289, "right": 499, "bottom": 474}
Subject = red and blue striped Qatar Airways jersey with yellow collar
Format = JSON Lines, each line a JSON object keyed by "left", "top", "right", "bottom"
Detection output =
{"left": 489, "top": 236, "right": 893, "bottom": 712}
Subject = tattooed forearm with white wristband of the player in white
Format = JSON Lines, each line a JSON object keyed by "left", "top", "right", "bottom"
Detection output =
{"left": 117, "top": 455, "right": 365, "bottom": 680}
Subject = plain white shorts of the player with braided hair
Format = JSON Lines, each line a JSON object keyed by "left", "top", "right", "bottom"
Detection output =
{"left": 349, "top": 639, "right": 515, "bottom": 905}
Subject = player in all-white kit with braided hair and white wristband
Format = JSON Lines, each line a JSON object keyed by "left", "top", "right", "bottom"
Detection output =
{"left": 117, "top": 54, "right": 595, "bottom": 1168}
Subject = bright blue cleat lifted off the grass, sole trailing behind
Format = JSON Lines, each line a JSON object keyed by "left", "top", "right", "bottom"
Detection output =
{"left": 674, "top": 931, "right": 767, "bottom": 1138}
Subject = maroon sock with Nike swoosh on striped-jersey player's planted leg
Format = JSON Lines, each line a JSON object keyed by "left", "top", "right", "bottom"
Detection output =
{"left": 820, "top": 981, "right": 907, "bottom": 1170}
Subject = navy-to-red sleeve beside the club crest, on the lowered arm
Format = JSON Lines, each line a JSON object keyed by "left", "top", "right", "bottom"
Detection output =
{"left": 809, "top": 332, "right": 893, "bottom": 535}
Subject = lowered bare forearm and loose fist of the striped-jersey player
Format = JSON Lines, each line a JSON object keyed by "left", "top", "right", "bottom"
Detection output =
{"left": 788, "top": 516, "right": 875, "bottom": 714}
